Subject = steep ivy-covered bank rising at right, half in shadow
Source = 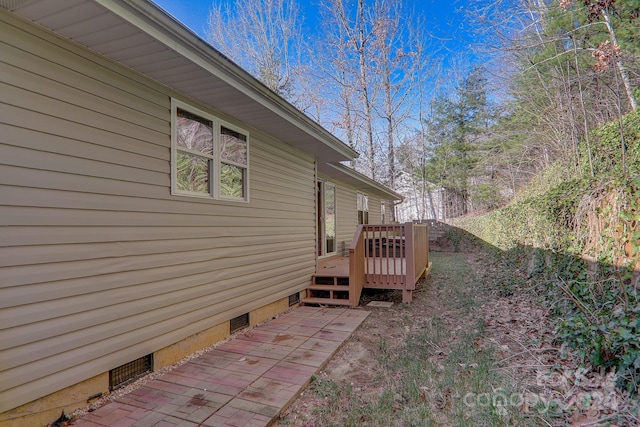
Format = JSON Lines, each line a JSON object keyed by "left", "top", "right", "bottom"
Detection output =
{"left": 454, "top": 111, "right": 640, "bottom": 394}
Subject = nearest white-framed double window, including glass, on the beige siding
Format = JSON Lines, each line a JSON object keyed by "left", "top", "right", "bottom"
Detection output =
{"left": 171, "top": 100, "right": 249, "bottom": 201}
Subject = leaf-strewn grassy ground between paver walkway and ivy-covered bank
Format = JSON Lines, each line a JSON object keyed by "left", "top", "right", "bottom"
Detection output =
{"left": 277, "top": 248, "right": 640, "bottom": 427}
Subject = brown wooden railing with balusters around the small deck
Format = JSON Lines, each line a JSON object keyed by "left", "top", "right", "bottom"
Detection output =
{"left": 349, "top": 222, "right": 429, "bottom": 305}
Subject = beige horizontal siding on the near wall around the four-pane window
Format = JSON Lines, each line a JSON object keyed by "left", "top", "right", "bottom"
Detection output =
{"left": 0, "top": 11, "right": 315, "bottom": 412}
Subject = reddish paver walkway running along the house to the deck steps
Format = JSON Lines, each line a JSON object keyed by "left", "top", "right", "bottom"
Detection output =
{"left": 74, "top": 307, "right": 369, "bottom": 427}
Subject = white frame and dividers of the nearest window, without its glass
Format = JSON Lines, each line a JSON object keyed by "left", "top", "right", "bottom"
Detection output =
{"left": 171, "top": 98, "right": 250, "bottom": 203}
